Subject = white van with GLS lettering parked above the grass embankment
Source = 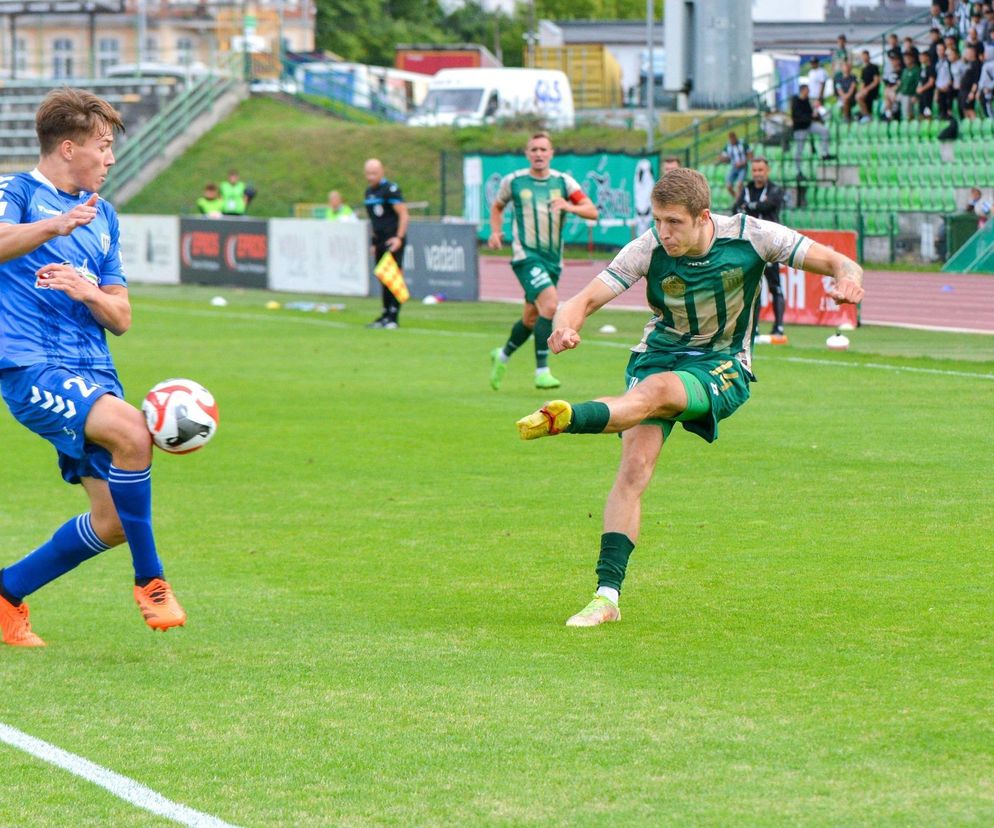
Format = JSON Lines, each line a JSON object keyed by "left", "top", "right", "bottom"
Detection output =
{"left": 407, "top": 69, "right": 576, "bottom": 129}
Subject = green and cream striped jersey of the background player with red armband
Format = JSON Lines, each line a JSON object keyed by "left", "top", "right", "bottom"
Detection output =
{"left": 496, "top": 169, "right": 586, "bottom": 267}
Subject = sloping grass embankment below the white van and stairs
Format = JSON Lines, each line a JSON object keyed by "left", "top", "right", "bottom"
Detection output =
{"left": 122, "top": 98, "right": 645, "bottom": 217}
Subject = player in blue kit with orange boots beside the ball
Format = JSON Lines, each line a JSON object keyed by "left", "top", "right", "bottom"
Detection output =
{"left": 0, "top": 88, "right": 186, "bottom": 647}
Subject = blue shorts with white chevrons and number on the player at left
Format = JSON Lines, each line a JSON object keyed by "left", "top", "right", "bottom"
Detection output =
{"left": 0, "top": 363, "right": 124, "bottom": 483}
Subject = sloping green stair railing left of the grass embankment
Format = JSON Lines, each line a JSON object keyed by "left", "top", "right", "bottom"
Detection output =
{"left": 100, "top": 55, "right": 242, "bottom": 199}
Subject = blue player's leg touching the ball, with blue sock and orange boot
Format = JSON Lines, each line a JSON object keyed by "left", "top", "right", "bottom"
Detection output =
{"left": 86, "top": 395, "right": 186, "bottom": 630}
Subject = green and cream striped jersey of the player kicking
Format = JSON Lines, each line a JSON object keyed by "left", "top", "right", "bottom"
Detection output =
{"left": 598, "top": 215, "right": 813, "bottom": 369}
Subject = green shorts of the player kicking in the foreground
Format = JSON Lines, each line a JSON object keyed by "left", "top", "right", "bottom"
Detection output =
{"left": 625, "top": 351, "right": 752, "bottom": 443}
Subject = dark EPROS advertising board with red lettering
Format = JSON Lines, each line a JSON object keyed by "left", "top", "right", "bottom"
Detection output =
{"left": 180, "top": 218, "right": 269, "bottom": 288}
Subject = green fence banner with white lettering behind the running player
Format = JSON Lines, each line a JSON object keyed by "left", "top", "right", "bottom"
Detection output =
{"left": 463, "top": 152, "right": 659, "bottom": 247}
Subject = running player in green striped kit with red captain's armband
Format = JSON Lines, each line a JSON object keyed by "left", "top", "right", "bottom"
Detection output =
{"left": 487, "top": 132, "right": 597, "bottom": 391}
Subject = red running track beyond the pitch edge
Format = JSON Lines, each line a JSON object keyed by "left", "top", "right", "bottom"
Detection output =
{"left": 480, "top": 256, "right": 994, "bottom": 334}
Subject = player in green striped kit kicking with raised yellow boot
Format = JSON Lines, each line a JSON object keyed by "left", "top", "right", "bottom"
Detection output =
{"left": 518, "top": 169, "right": 863, "bottom": 627}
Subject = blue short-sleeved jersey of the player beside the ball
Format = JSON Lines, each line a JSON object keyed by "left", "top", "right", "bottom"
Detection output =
{"left": 0, "top": 170, "right": 127, "bottom": 370}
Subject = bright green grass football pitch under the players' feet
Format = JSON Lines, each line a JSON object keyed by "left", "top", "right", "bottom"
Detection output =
{"left": 0, "top": 287, "right": 994, "bottom": 826}
